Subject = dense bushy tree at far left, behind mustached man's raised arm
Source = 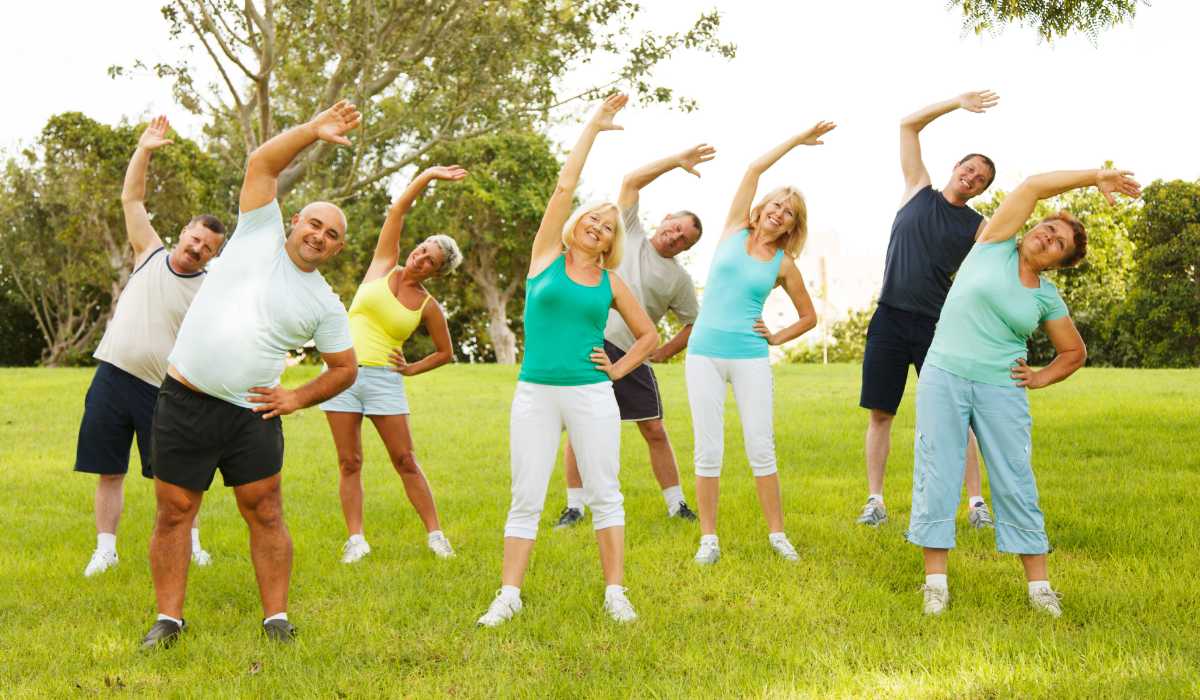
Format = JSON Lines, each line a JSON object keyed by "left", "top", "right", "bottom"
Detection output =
{"left": 0, "top": 113, "right": 234, "bottom": 365}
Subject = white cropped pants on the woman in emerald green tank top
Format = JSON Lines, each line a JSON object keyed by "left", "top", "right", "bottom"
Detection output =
{"left": 504, "top": 382, "right": 625, "bottom": 539}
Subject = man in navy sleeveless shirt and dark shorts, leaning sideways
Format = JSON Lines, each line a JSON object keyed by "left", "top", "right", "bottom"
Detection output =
{"left": 858, "top": 90, "right": 998, "bottom": 527}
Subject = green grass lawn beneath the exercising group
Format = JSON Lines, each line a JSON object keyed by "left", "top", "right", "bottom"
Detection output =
{"left": 0, "top": 365, "right": 1200, "bottom": 698}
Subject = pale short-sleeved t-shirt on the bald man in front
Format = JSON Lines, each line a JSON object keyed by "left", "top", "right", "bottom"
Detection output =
{"left": 168, "top": 201, "right": 354, "bottom": 408}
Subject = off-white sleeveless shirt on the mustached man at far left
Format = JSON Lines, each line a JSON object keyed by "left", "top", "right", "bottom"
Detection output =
{"left": 92, "top": 247, "right": 204, "bottom": 387}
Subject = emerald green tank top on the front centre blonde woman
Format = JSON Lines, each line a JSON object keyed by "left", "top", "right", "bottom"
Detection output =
{"left": 517, "top": 255, "right": 612, "bottom": 387}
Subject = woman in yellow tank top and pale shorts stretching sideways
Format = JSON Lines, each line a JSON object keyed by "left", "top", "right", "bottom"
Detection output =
{"left": 320, "top": 166, "right": 467, "bottom": 563}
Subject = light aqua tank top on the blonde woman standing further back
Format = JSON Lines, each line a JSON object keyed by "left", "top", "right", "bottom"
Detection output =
{"left": 688, "top": 228, "right": 784, "bottom": 360}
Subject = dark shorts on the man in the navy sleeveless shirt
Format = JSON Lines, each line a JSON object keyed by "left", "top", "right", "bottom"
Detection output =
{"left": 858, "top": 304, "right": 937, "bottom": 415}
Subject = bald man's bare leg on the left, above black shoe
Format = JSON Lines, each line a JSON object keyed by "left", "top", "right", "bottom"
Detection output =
{"left": 150, "top": 479, "right": 204, "bottom": 620}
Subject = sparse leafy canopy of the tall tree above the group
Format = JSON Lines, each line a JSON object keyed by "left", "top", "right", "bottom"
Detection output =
{"left": 121, "top": 0, "right": 734, "bottom": 202}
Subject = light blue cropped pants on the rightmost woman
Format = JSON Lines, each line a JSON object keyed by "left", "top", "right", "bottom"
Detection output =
{"left": 905, "top": 363, "right": 1050, "bottom": 555}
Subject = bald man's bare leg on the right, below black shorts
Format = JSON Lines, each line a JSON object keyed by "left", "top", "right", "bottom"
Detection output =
{"left": 233, "top": 474, "right": 292, "bottom": 617}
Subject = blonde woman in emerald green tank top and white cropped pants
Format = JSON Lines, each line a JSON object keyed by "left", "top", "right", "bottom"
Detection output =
{"left": 479, "top": 95, "right": 658, "bottom": 627}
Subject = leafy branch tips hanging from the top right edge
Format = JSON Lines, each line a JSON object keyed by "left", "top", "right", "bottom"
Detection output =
{"left": 948, "top": 0, "right": 1150, "bottom": 41}
